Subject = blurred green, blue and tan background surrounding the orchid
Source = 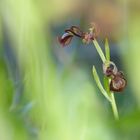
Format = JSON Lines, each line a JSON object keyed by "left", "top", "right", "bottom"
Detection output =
{"left": 0, "top": 0, "right": 140, "bottom": 140}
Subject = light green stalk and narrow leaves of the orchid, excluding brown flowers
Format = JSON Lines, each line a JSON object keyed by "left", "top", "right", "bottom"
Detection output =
{"left": 93, "top": 39, "right": 119, "bottom": 120}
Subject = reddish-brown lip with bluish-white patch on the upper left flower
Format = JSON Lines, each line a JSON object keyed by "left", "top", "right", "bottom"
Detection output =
{"left": 58, "top": 33, "right": 73, "bottom": 47}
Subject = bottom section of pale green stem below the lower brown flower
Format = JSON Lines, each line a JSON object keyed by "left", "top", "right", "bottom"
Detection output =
{"left": 110, "top": 92, "right": 119, "bottom": 120}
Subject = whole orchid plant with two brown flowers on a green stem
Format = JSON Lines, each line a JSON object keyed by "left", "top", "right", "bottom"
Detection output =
{"left": 58, "top": 23, "right": 127, "bottom": 120}
